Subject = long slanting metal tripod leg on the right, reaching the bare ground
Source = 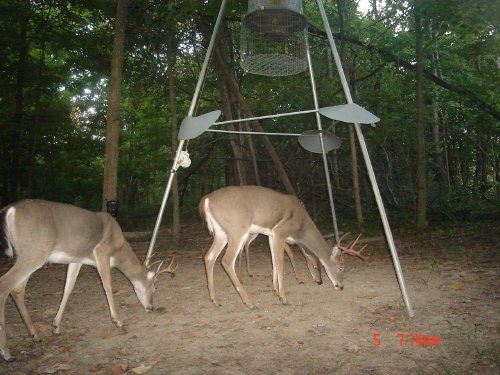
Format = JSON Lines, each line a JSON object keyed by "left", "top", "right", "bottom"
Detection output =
{"left": 317, "top": 0, "right": 414, "bottom": 318}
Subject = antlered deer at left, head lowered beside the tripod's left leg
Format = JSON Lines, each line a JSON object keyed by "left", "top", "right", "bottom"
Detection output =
{"left": 0, "top": 199, "right": 177, "bottom": 361}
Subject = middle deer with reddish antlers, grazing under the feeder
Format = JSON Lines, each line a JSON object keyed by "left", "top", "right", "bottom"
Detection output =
{"left": 198, "top": 185, "right": 364, "bottom": 308}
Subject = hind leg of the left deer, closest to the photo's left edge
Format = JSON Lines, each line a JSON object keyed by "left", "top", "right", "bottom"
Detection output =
{"left": 0, "top": 260, "right": 43, "bottom": 361}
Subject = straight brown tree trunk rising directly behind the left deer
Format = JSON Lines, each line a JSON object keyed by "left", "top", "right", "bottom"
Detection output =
{"left": 102, "top": 0, "right": 128, "bottom": 211}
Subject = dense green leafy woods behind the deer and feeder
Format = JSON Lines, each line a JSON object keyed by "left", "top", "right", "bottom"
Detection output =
{"left": 0, "top": 0, "right": 500, "bottom": 236}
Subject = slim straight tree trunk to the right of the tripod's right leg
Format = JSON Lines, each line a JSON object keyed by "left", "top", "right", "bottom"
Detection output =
{"left": 414, "top": 2, "right": 427, "bottom": 230}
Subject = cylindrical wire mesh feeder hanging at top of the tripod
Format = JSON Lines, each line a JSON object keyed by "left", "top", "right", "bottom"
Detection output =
{"left": 241, "top": 0, "right": 307, "bottom": 77}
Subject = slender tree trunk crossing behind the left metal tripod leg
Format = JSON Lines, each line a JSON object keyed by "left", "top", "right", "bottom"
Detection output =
{"left": 167, "top": 30, "right": 181, "bottom": 241}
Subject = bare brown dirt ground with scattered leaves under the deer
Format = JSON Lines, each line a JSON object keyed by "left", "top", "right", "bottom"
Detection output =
{"left": 0, "top": 222, "right": 500, "bottom": 375}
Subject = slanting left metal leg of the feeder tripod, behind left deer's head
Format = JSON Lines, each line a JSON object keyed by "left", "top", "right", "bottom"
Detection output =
{"left": 144, "top": 0, "right": 227, "bottom": 266}
